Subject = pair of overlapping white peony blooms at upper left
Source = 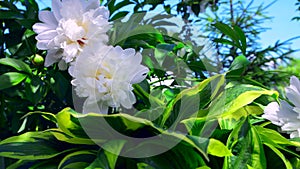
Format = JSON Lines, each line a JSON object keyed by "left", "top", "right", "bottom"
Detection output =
{"left": 33, "top": 0, "right": 148, "bottom": 114}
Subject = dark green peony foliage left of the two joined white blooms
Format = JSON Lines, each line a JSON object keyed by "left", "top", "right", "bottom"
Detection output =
{"left": 0, "top": 0, "right": 72, "bottom": 139}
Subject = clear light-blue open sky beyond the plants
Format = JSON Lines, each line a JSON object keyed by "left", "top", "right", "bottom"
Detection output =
{"left": 38, "top": 0, "right": 300, "bottom": 58}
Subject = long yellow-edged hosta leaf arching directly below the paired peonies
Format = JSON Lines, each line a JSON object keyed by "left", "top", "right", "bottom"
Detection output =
{"left": 57, "top": 108, "right": 208, "bottom": 166}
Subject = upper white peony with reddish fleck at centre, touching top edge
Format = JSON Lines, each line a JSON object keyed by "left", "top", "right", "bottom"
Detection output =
{"left": 33, "top": 0, "right": 110, "bottom": 69}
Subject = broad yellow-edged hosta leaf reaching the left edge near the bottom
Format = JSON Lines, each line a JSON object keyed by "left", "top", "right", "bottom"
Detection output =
{"left": 0, "top": 132, "right": 71, "bottom": 160}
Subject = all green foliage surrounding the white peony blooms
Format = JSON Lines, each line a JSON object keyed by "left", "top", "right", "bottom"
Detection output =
{"left": 0, "top": 0, "right": 300, "bottom": 169}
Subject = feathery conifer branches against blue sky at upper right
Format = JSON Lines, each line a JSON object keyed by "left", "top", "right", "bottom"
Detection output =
{"left": 194, "top": 0, "right": 297, "bottom": 87}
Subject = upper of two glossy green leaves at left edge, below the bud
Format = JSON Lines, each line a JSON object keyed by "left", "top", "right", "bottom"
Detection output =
{"left": 0, "top": 58, "right": 31, "bottom": 74}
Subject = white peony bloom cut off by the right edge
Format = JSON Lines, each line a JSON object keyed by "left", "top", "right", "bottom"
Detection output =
{"left": 262, "top": 76, "right": 300, "bottom": 138}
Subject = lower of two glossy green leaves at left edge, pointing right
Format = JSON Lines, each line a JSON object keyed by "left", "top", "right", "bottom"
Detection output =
{"left": 0, "top": 72, "right": 27, "bottom": 90}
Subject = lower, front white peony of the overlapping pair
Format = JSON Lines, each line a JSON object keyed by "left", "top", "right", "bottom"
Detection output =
{"left": 69, "top": 45, "right": 148, "bottom": 114}
